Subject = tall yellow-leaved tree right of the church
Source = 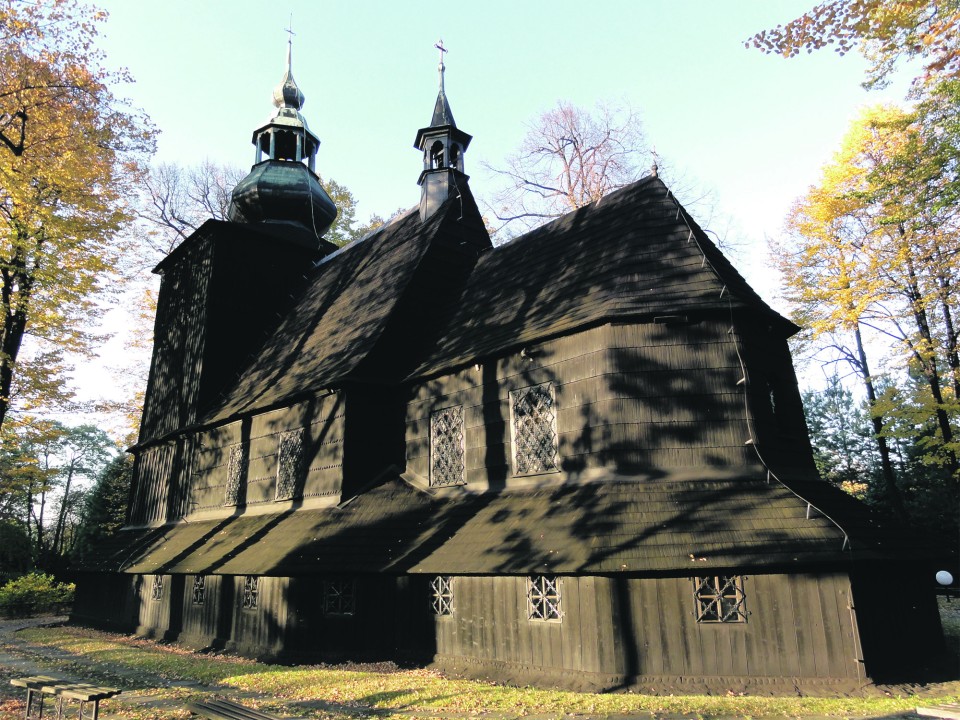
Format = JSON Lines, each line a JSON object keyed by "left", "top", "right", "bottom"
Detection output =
{"left": 774, "top": 107, "right": 960, "bottom": 516}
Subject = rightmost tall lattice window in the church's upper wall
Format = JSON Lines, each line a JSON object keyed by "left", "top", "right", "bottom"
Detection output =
{"left": 510, "top": 383, "right": 560, "bottom": 475}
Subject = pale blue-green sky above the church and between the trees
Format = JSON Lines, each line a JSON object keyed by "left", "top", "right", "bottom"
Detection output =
{"left": 75, "top": 0, "right": 909, "bottom": 430}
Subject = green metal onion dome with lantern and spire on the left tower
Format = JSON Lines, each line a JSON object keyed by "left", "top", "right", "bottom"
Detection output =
{"left": 229, "top": 37, "right": 337, "bottom": 247}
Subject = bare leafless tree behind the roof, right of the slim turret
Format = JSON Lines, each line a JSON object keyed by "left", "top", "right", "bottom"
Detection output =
{"left": 487, "top": 101, "right": 649, "bottom": 227}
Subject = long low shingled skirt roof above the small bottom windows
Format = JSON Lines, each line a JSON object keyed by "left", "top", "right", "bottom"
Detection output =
{"left": 78, "top": 478, "right": 920, "bottom": 576}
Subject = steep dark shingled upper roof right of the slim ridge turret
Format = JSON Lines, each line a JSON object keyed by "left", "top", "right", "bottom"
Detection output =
{"left": 414, "top": 177, "right": 795, "bottom": 377}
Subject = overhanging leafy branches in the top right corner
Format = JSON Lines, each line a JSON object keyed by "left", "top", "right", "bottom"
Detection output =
{"left": 744, "top": 0, "right": 960, "bottom": 87}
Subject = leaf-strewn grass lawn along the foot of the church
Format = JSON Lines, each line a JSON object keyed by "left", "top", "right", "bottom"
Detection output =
{"left": 0, "top": 600, "right": 960, "bottom": 720}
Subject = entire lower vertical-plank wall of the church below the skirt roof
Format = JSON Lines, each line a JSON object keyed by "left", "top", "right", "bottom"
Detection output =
{"left": 76, "top": 572, "right": 862, "bottom": 683}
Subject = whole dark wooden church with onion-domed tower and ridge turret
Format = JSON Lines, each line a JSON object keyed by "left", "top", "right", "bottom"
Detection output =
{"left": 72, "top": 43, "right": 942, "bottom": 691}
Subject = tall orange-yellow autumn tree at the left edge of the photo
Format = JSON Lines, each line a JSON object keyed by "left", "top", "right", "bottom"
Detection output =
{"left": 0, "top": 0, "right": 153, "bottom": 427}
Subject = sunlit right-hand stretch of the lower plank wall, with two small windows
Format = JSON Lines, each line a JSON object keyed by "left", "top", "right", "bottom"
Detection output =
{"left": 434, "top": 573, "right": 861, "bottom": 680}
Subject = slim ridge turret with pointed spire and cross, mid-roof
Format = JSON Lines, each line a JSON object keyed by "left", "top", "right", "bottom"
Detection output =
{"left": 414, "top": 40, "right": 473, "bottom": 221}
